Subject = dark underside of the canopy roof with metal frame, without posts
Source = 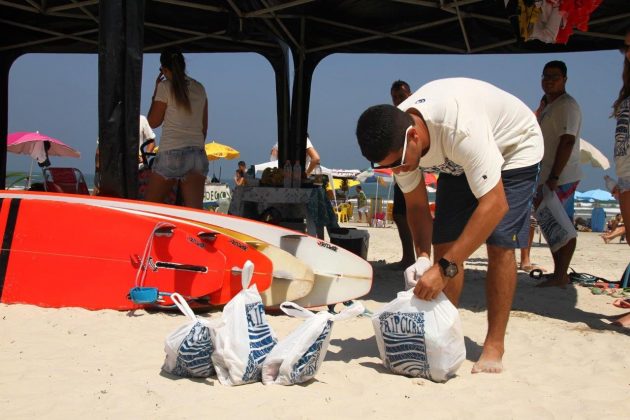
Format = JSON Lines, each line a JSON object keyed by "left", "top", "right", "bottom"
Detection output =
{"left": 0, "top": 0, "right": 630, "bottom": 56}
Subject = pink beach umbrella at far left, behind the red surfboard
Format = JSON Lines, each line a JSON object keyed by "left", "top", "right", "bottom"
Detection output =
{"left": 7, "top": 131, "right": 81, "bottom": 188}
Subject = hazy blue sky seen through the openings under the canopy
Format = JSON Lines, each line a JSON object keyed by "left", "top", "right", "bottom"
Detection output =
{"left": 7, "top": 50, "right": 623, "bottom": 191}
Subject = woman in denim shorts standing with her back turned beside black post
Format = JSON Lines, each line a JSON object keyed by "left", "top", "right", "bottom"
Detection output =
{"left": 145, "top": 50, "right": 208, "bottom": 209}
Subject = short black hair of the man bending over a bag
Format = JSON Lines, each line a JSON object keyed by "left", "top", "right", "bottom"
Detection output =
{"left": 356, "top": 104, "right": 413, "bottom": 162}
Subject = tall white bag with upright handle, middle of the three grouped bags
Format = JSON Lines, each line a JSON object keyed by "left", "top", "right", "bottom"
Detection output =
{"left": 211, "top": 261, "right": 277, "bottom": 385}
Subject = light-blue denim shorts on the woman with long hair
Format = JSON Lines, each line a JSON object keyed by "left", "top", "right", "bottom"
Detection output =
{"left": 152, "top": 147, "right": 210, "bottom": 180}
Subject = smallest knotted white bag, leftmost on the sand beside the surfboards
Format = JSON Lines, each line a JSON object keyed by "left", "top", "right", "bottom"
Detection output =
{"left": 162, "top": 293, "right": 214, "bottom": 378}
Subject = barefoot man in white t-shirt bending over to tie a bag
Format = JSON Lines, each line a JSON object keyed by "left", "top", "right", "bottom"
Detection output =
{"left": 356, "top": 78, "right": 543, "bottom": 373}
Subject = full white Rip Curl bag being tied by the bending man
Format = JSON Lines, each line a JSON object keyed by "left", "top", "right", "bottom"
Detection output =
{"left": 372, "top": 290, "right": 466, "bottom": 382}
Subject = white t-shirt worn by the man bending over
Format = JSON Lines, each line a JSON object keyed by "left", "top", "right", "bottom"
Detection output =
{"left": 395, "top": 78, "right": 544, "bottom": 198}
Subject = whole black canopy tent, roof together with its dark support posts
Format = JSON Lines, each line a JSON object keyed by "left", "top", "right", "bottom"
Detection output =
{"left": 0, "top": 0, "right": 630, "bottom": 192}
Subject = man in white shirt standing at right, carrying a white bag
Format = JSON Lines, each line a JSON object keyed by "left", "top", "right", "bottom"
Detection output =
{"left": 537, "top": 61, "right": 582, "bottom": 287}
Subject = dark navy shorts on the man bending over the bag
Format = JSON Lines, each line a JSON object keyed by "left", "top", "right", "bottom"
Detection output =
{"left": 433, "top": 164, "right": 540, "bottom": 249}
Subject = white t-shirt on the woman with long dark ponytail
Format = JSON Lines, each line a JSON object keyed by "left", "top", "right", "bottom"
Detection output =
{"left": 155, "top": 78, "right": 206, "bottom": 152}
